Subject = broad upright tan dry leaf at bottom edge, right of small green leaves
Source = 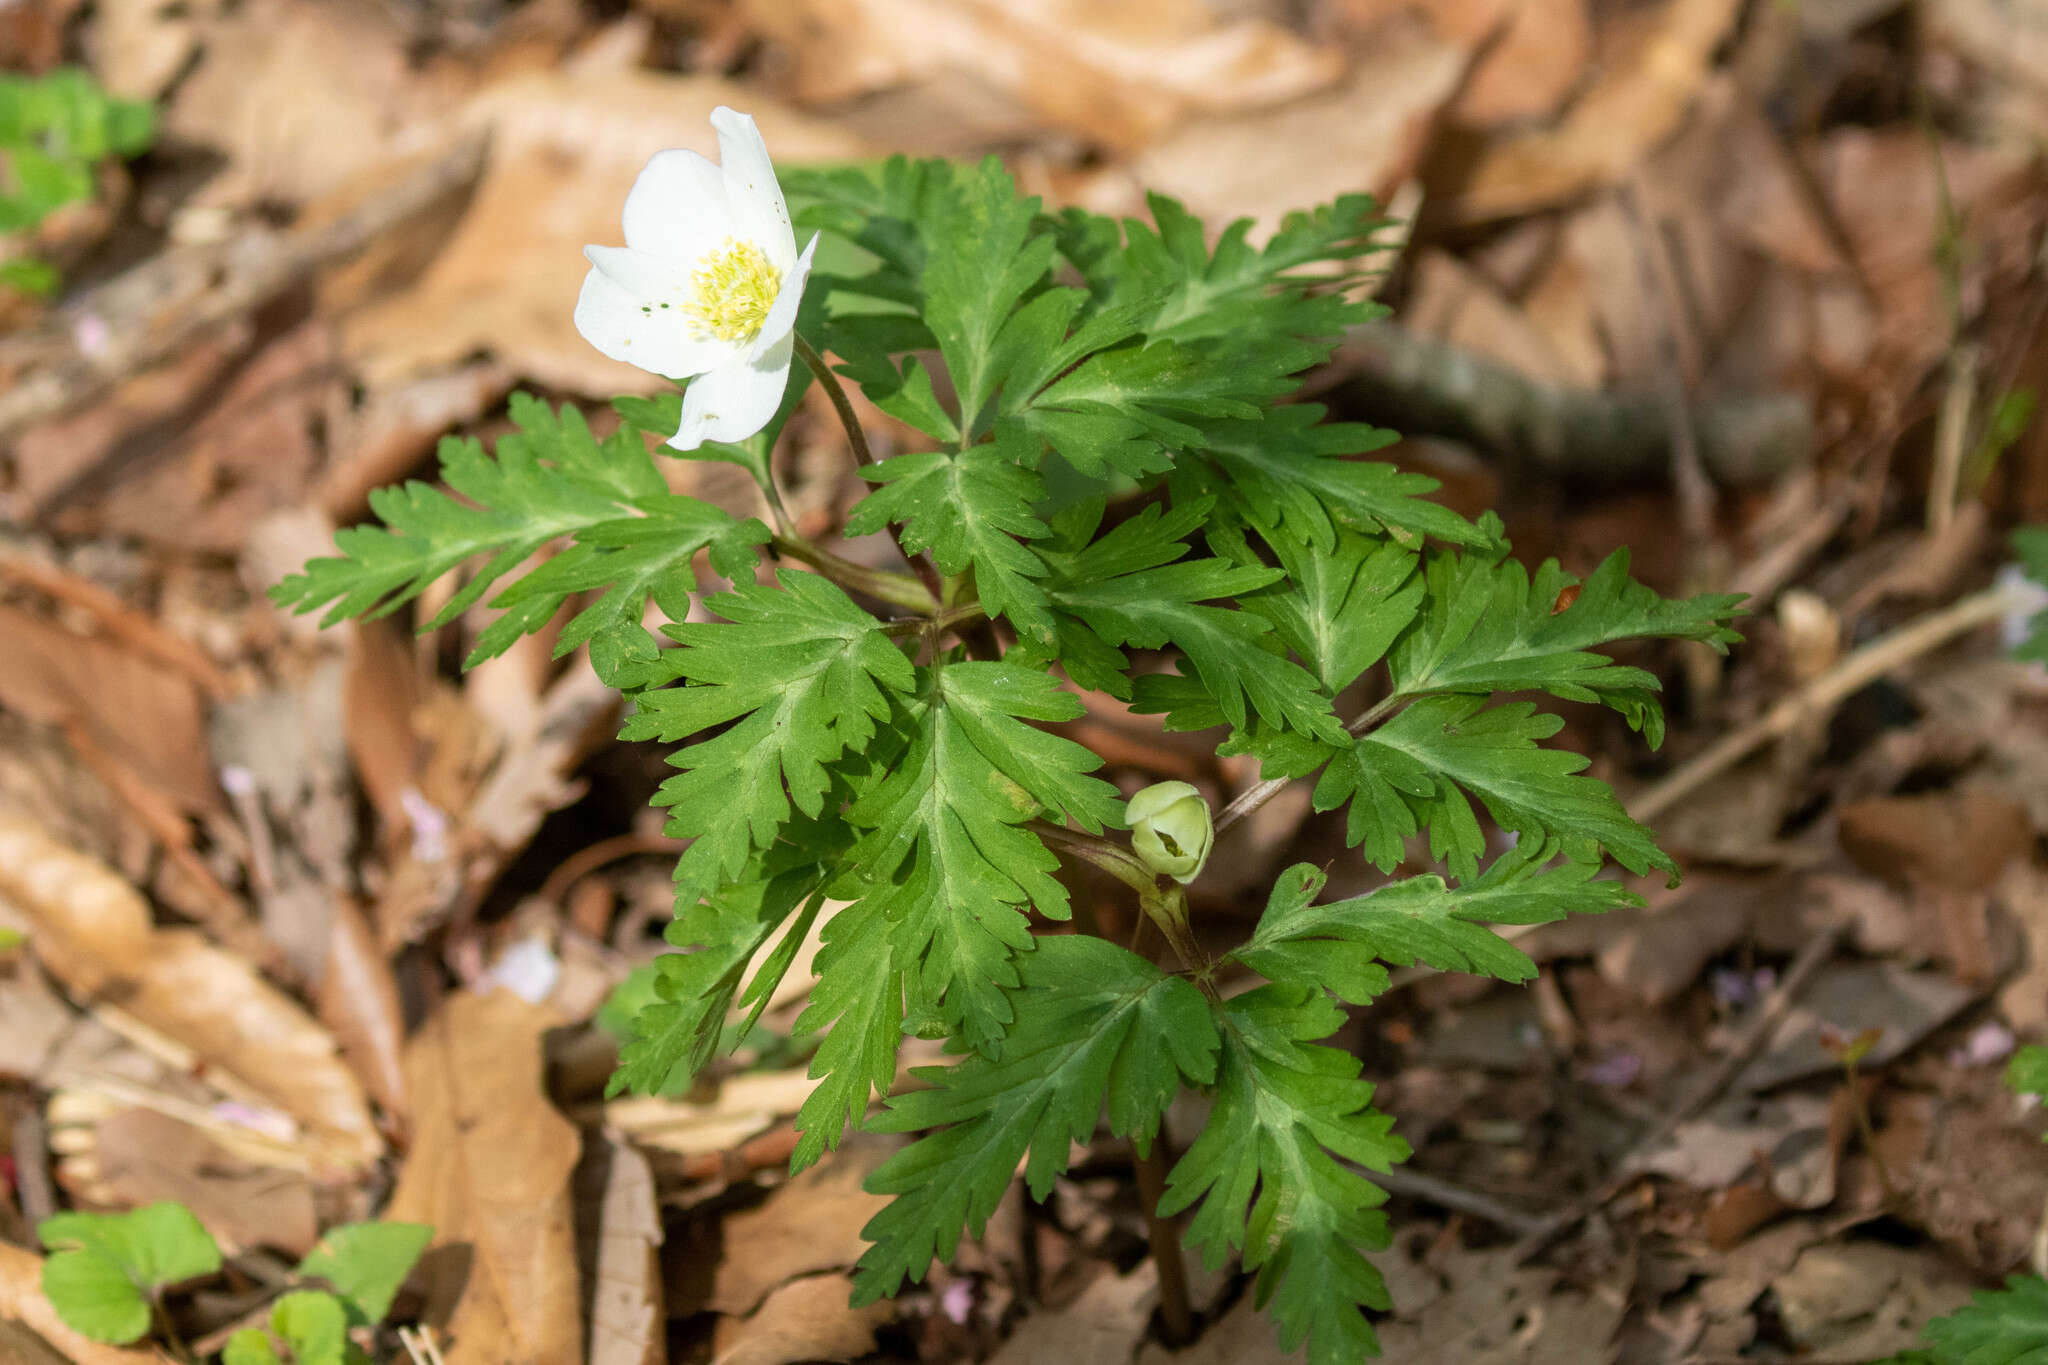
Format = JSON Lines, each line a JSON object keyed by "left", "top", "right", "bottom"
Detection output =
{"left": 385, "top": 990, "right": 582, "bottom": 1365}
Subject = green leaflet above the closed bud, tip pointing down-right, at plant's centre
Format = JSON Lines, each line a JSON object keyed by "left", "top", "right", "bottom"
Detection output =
{"left": 1051, "top": 503, "right": 1348, "bottom": 745}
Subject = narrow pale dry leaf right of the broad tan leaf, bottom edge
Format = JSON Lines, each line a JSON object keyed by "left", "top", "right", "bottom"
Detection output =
{"left": 575, "top": 1134, "right": 668, "bottom": 1365}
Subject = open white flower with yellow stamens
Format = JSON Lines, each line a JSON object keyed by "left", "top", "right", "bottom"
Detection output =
{"left": 575, "top": 106, "right": 817, "bottom": 450}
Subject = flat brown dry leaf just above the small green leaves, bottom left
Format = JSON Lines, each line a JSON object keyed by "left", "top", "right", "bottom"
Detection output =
{"left": 94, "top": 1109, "right": 319, "bottom": 1257}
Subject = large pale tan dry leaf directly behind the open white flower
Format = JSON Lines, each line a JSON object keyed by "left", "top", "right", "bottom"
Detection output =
{"left": 344, "top": 72, "right": 862, "bottom": 397}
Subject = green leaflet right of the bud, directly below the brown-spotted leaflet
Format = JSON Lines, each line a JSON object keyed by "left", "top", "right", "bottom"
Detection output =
{"left": 1315, "top": 696, "right": 1677, "bottom": 880}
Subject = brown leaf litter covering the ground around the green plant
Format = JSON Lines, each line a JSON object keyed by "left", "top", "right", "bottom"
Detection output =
{"left": 0, "top": 0, "right": 2048, "bottom": 1365}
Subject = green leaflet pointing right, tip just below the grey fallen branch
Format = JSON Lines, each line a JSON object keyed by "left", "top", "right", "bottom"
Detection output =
{"left": 1202, "top": 403, "right": 1495, "bottom": 551}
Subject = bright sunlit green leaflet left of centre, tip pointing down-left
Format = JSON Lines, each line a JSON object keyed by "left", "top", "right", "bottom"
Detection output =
{"left": 621, "top": 571, "right": 915, "bottom": 905}
